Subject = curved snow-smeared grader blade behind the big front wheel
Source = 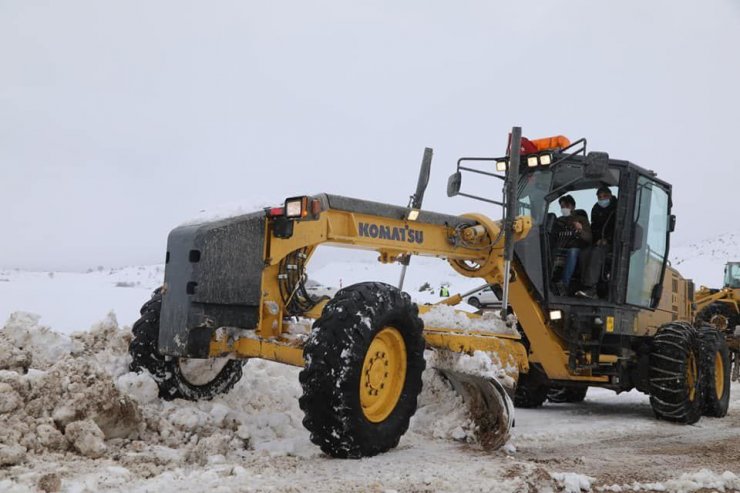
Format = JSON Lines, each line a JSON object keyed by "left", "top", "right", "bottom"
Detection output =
{"left": 437, "top": 368, "right": 514, "bottom": 450}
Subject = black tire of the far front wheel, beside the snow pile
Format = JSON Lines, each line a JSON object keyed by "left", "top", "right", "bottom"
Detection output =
{"left": 129, "top": 289, "right": 243, "bottom": 401}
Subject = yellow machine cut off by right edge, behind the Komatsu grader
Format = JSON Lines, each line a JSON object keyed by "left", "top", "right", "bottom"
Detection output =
{"left": 694, "top": 262, "right": 740, "bottom": 381}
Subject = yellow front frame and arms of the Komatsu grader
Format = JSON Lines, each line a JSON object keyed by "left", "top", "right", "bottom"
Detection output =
{"left": 210, "top": 204, "right": 616, "bottom": 383}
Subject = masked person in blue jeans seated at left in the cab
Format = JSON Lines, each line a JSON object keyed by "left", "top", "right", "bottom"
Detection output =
{"left": 553, "top": 195, "right": 591, "bottom": 296}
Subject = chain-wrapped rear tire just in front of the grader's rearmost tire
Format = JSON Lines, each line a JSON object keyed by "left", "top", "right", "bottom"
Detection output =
{"left": 649, "top": 322, "right": 704, "bottom": 424}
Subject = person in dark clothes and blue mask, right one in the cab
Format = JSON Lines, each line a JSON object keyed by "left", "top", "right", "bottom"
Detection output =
{"left": 576, "top": 186, "right": 617, "bottom": 298}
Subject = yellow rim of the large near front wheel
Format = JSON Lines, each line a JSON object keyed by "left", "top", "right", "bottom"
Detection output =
{"left": 360, "top": 327, "right": 406, "bottom": 423}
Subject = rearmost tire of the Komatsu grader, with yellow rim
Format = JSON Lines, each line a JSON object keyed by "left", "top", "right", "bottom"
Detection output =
{"left": 699, "top": 326, "right": 731, "bottom": 418}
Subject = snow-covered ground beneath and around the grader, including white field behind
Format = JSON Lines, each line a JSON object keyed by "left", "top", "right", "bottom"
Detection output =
{"left": 0, "top": 242, "right": 740, "bottom": 492}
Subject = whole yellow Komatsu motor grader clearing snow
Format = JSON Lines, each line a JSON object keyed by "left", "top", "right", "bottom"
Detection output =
{"left": 130, "top": 127, "right": 730, "bottom": 458}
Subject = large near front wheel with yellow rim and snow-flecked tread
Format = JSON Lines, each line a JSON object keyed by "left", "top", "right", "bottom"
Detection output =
{"left": 299, "top": 282, "right": 425, "bottom": 459}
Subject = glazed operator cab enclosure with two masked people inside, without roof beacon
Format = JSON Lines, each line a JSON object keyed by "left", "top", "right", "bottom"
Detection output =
{"left": 515, "top": 146, "right": 674, "bottom": 309}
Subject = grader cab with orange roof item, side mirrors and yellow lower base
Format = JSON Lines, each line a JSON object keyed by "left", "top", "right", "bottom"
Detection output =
{"left": 448, "top": 136, "right": 676, "bottom": 356}
